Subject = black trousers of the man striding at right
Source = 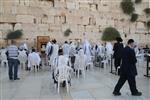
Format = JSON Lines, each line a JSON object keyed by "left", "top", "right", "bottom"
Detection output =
{"left": 114, "top": 76, "right": 138, "bottom": 94}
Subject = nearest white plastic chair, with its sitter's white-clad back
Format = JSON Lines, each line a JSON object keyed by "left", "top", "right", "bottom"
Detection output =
{"left": 54, "top": 56, "right": 72, "bottom": 93}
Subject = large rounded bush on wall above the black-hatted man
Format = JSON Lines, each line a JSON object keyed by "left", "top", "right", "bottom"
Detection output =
{"left": 102, "top": 27, "right": 120, "bottom": 41}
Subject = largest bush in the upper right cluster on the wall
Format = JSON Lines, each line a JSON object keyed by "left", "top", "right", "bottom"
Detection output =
{"left": 121, "top": 0, "right": 135, "bottom": 15}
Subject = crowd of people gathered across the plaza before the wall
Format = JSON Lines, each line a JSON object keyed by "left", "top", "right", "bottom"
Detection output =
{"left": 0, "top": 37, "right": 148, "bottom": 96}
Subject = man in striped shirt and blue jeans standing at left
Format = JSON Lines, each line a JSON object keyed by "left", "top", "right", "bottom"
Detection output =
{"left": 6, "top": 40, "right": 19, "bottom": 80}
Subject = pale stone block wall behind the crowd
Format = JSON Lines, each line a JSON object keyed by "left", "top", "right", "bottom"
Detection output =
{"left": 0, "top": 0, "right": 150, "bottom": 45}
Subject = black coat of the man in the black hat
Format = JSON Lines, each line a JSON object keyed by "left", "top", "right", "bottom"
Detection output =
{"left": 113, "top": 43, "right": 123, "bottom": 58}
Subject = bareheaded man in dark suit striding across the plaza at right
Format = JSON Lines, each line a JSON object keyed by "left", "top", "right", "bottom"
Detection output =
{"left": 113, "top": 39, "right": 142, "bottom": 96}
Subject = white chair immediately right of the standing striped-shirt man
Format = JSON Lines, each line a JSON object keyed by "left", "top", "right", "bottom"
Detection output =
{"left": 18, "top": 50, "right": 28, "bottom": 68}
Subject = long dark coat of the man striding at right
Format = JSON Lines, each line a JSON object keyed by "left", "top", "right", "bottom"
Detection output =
{"left": 120, "top": 46, "right": 137, "bottom": 76}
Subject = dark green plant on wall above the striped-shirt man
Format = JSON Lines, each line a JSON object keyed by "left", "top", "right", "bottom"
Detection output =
{"left": 6, "top": 30, "right": 23, "bottom": 39}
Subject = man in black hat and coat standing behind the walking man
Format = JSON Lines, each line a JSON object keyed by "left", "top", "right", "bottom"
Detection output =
{"left": 113, "top": 37, "right": 123, "bottom": 72}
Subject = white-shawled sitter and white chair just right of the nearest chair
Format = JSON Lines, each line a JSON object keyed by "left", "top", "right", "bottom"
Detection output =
{"left": 74, "top": 50, "right": 86, "bottom": 78}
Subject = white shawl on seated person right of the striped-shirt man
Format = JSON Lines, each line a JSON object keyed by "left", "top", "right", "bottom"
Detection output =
{"left": 28, "top": 52, "right": 41, "bottom": 67}
